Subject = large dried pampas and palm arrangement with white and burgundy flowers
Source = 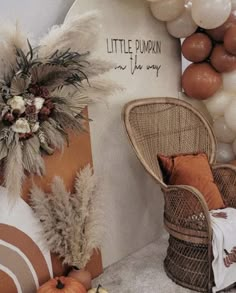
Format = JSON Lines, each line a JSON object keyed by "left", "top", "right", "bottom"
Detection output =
{"left": 0, "top": 12, "right": 115, "bottom": 196}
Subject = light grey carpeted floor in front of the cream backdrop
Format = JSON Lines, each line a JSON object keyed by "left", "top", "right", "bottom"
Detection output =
{"left": 93, "top": 234, "right": 236, "bottom": 293}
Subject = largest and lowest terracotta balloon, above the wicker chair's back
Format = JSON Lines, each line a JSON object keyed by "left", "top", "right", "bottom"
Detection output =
{"left": 182, "top": 62, "right": 222, "bottom": 100}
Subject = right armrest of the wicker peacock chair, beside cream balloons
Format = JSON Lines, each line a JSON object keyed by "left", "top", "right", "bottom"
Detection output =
{"left": 212, "top": 164, "right": 236, "bottom": 208}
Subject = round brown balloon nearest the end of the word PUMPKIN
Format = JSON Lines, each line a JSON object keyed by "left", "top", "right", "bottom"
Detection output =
{"left": 182, "top": 33, "right": 212, "bottom": 62}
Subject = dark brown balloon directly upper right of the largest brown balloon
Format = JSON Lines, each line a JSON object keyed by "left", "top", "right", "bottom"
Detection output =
{"left": 210, "top": 44, "right": 236, "bottom": 72}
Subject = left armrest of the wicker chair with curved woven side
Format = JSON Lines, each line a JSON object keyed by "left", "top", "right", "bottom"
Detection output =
{"left": 162, "top": 185, "right": 212, "bottom": 243}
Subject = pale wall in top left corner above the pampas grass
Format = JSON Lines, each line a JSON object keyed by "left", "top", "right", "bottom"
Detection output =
{"left": 0, "top": 0, "right": 74, "bottom": 37}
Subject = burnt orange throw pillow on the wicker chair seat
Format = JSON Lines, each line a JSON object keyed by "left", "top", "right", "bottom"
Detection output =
{"left": 158, "top": 153, "right": 225, "bottom": 210}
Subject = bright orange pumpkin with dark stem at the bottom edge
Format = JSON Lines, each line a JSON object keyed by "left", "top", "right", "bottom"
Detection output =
{"left": 37, "top": 277, "right": 86, "bottom": 293}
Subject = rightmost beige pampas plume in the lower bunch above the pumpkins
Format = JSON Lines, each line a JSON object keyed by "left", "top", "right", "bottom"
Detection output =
{"left": 72, "top": 165, "right": 104, "bottom": 268}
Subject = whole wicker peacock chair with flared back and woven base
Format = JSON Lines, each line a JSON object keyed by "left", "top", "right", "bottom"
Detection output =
{"left": 123, "top": 98, "right": 236, "bottom": 292}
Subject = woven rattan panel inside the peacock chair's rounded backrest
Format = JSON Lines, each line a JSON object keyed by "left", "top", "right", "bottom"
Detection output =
{"left": 129, "top": 100, "right": 216, "bottom": 184}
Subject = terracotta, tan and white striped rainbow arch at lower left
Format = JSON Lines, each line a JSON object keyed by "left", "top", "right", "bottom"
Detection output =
{"left": 0, "top": 224, "right": 51, "bottom": 293}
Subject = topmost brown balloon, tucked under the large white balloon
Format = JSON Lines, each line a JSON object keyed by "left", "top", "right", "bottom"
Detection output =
{"left": 206, "top": 10, "right": 236, "bottom": 42}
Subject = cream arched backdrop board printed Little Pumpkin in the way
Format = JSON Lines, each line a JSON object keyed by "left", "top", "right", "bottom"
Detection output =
{"left": 67, "top": 0, "right": 181, "bottom": 266}
